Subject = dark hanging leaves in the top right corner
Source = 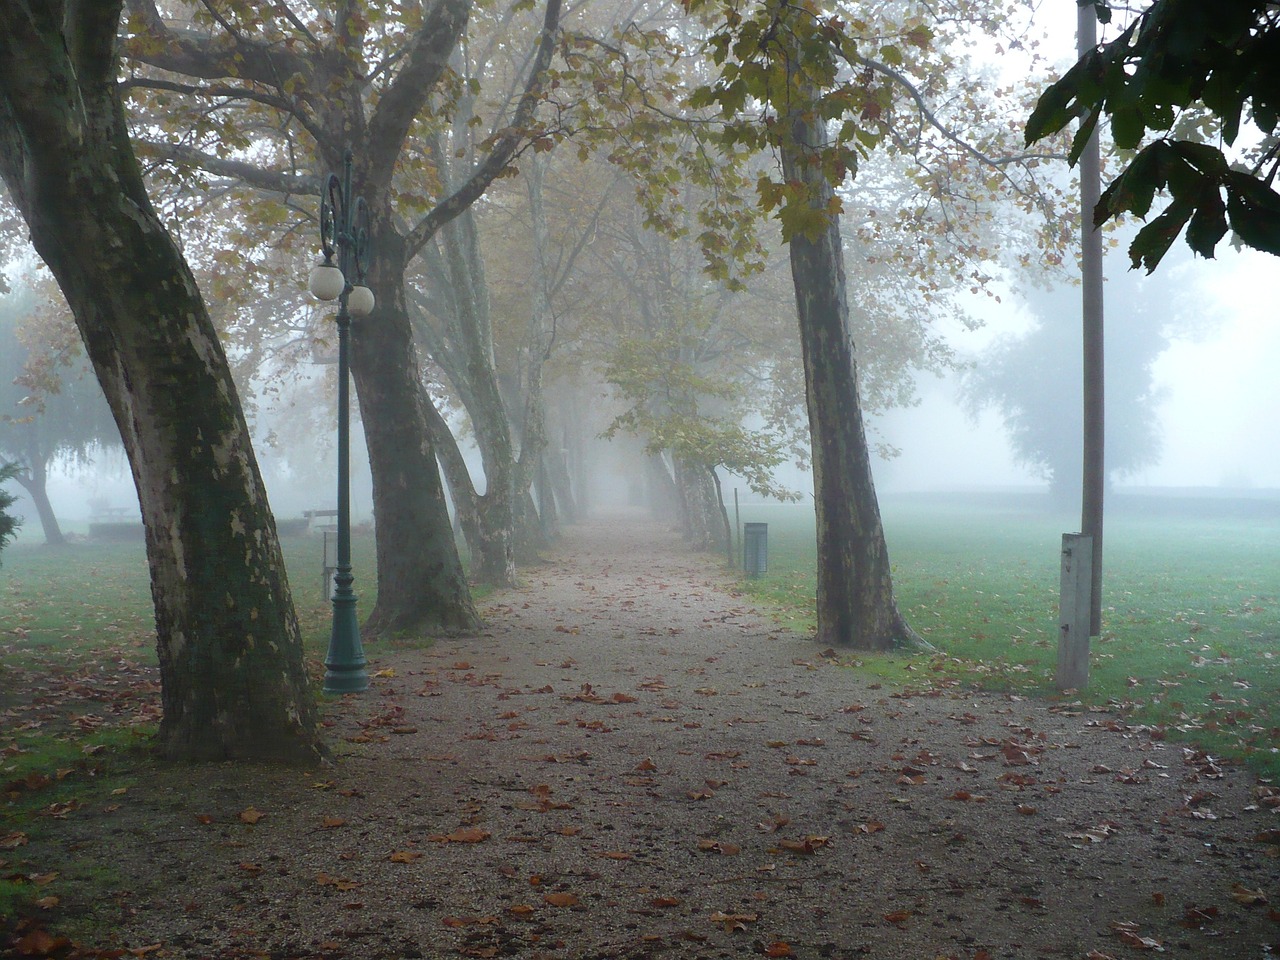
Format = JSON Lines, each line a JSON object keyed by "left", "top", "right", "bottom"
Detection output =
{"left": 1027, "top": 0, "right": 1280, "bottom": 273}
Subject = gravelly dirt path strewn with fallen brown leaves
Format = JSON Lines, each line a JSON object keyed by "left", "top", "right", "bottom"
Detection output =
{"left": 17, "top": 518, "right": 1280, "bottom": 960}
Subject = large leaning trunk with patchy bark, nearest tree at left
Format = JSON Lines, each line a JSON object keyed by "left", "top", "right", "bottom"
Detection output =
{"left": 0, "top": 0, "right": 317, "bottom": 759}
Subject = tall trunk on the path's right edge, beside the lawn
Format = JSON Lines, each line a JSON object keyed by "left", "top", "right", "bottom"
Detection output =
{"left": 782, "top": 88, "right": 918, "bottom": 650}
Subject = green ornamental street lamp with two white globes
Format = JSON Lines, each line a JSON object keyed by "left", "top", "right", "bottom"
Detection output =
{"left": 311, "top": 150, "right": 374, "bottom": 694}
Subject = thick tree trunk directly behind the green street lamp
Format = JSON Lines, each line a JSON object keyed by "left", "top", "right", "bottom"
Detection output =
{"left": 351, "top": 220, "right": 480, "bottom": 636}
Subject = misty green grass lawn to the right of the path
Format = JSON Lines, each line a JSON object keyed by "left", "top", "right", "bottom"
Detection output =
{"left": 742, "top": 495, "right": 1280, "bottom": 774}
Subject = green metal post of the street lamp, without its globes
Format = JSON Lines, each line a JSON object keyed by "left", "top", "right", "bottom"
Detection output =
{"left": 324, "top": 150, "right": 369, "bottom": 694}
